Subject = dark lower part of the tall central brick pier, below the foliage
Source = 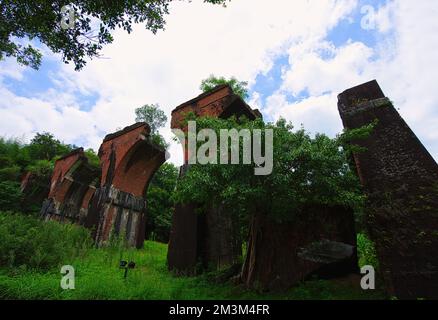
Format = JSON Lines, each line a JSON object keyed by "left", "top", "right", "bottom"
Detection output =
{"left": 167, "top": 166, "right": 242, "bottom": 275}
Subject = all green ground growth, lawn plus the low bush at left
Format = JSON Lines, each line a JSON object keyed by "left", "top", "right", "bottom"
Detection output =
{"left": 0, "top": 214, "right": 384, "bottom": 300}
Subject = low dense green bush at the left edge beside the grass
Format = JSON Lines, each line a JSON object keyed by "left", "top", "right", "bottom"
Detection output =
{"left": 0, "top": 212, "right": 92, "bottom": 270}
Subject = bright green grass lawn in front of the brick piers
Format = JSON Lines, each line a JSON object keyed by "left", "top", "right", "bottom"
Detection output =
{"left": 0, "top": 241, "right": 385, "bottom": 300}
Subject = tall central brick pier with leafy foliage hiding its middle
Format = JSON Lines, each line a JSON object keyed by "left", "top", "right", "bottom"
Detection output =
{"left": 167, "top": 85, "right": 261, "bottom": 274}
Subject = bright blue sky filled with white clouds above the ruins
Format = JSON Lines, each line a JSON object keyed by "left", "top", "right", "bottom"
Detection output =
{"left": 0, "top": 0, "right": 438, "bottom": 164}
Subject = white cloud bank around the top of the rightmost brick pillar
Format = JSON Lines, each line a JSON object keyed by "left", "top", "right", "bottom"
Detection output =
{"left": 265, "top": 0, "right": 438, "bottom": 159}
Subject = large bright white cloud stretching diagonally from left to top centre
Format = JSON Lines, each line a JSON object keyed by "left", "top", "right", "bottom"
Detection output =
{"left": 0, "top": 0, "right": 357, "bottom": 162}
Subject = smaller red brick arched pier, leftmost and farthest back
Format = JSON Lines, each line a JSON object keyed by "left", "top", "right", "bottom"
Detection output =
{"left": 41, "top": 148, "right": 99, "bottom": 227}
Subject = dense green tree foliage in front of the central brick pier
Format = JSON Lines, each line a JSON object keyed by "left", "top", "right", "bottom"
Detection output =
{"left": 175, "top": 114, "right": 363, "bottom": 221}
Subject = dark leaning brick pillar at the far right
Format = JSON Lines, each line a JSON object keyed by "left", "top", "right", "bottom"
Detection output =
{"left": 338, "top": 81, "right": 438, "bottom": 298}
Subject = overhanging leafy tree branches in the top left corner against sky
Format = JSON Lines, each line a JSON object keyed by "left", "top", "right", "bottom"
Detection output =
{"left": 0, "top": 0, "right": 227, "bottom": 70}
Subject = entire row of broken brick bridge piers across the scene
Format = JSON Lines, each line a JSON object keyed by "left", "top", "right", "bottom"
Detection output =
{"left": 31, "top": 81, "right": 438, "bottom": 298}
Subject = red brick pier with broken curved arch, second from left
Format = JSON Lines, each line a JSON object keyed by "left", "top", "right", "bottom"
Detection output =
{"left": 91, "top": 123, "right": 166, "bottom": 247}
